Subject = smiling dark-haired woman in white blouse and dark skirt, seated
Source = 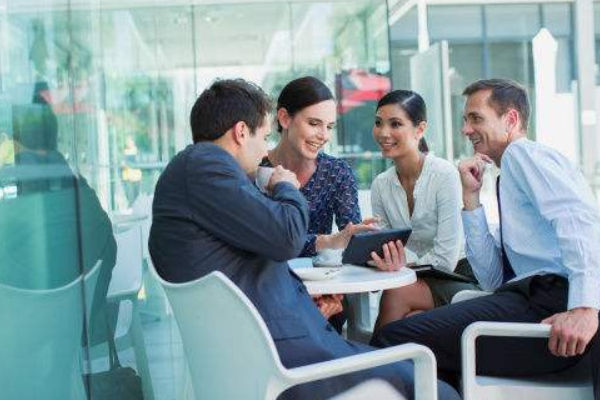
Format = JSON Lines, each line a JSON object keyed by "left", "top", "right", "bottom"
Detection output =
{"left": 371, "top": 90, "right": 477, "bottom": 329}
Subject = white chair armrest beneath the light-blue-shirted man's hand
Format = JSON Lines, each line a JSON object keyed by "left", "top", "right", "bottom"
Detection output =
{"left": 462, "top": 322, "right": 550, "bottom": 390}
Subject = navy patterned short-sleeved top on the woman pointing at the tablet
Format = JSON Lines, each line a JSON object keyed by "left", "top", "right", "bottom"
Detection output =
{"left": 261, "top": 153, "right": 362, "bottom": 257}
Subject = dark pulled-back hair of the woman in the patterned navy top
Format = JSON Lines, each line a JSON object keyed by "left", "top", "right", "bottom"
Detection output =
{"left": 277, "top": 76, "right": 333, "bottom": 132}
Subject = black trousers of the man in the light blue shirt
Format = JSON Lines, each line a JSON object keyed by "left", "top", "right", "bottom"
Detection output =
{"left": 371, "top": 275, "right": 600, "bottom": 400}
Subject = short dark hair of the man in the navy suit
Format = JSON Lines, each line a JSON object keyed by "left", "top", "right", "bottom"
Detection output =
{"left": 190, "top": 79, "right": 272, "bottom": 143}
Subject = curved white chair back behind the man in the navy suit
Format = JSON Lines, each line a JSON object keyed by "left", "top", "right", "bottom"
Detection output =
{"left": 153, "top": 271, "right": 283, "bottom": 400}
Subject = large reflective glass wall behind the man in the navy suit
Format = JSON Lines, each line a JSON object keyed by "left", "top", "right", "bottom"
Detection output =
{"left": 0, "top": 0, "right": 391, "bottom": 400}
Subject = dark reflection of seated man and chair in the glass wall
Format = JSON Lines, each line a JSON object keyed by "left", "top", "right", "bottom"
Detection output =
{"left": 0, "top": 83, "right": 116, "bottom": 400}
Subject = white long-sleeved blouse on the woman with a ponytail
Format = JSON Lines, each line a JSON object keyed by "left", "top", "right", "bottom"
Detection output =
{"left": 371, "top": 154, "right": 464, "bottom": 271}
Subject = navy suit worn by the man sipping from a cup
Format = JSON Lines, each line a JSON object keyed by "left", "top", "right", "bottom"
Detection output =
{"left": 150, "top": 142, "right": 412, "bottom": 399}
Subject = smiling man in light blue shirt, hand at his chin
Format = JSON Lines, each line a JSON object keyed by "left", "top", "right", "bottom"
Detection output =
{"left": 373, "top": 79, "right": 600, "bottom": 399}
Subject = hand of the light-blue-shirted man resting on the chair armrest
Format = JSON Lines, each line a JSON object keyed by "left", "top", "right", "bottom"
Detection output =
{"left": 542, "top": 307, "right": 598, "bottom": 357}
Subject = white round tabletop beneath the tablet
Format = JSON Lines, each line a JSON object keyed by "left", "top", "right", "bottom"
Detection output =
{"left": 303, "top": 265, "right": 417, "bottom": 295}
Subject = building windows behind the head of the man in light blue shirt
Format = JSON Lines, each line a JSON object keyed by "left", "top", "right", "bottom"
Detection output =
{"left": 390, "top": 3, "right": 574, "bottom": 163}
